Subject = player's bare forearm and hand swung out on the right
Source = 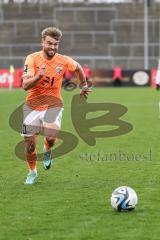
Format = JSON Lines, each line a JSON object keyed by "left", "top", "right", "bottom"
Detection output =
{"left": 75, "top": 63, "right": 90, "bottom": 98}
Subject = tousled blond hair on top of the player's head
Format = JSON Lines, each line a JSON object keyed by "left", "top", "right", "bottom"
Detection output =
{"left": 41, "top": 27, "right": 62, "bottom": 40}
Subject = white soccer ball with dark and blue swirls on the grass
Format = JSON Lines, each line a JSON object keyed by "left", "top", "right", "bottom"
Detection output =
{"left": 111, "top": 186, "right": 138, "bottom": 212}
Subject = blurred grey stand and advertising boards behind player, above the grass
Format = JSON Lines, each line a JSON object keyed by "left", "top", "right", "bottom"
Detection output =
{"left": 0, "top": 0, "right": 160, "bottom": 87}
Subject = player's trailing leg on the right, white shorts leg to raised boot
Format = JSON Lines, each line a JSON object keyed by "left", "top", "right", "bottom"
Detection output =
{"left": 43, "top": 108, "right": 63, "bottom": 170}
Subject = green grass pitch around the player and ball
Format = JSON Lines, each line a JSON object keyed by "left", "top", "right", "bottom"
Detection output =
{"left": 0, "top": 88, "right": 160, "bottom": 240}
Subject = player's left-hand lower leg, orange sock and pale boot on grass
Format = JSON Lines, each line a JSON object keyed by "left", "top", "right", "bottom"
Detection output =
{"left": 24, "top": 136, "right": 38, "bottom": 184}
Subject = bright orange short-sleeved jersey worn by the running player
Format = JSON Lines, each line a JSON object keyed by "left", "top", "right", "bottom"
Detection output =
{"left": 23, "top": 51, "right": 77, "bottom": 111}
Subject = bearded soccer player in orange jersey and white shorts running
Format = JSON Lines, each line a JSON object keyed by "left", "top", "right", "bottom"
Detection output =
{"left": 22, "top": 27, "right": 89, "bottom": 184}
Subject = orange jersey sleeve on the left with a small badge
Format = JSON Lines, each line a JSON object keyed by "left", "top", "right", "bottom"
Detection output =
{"left": 23, "top": 55, "right": 35, "bottom": 76}
